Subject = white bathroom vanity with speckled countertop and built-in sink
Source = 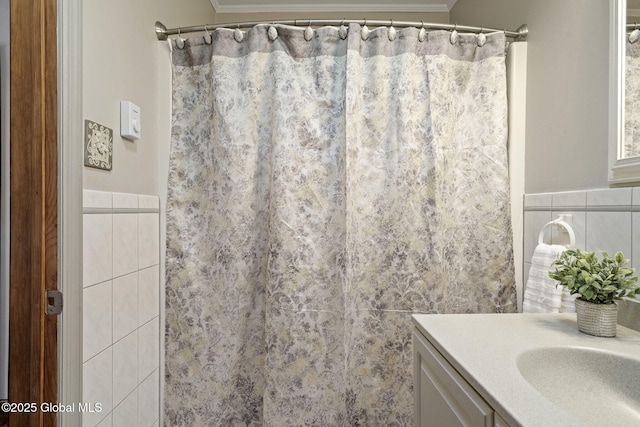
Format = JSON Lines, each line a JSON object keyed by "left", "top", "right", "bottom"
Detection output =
{"left": 412, "top": 313, "right": 640, "bottom": 427}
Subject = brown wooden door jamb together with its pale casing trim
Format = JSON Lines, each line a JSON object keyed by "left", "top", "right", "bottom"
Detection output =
{"left": 9, "top": 0, "right": 83, "bottom": 427}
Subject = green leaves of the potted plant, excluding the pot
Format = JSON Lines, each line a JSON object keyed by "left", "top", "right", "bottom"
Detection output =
{"left": 549, "top": 248, "right": 640, "bottom": 304}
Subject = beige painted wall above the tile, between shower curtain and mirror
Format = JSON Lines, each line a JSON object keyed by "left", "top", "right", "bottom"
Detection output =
{"left": 451, "top": 0, "right": 609, "bottom": 193}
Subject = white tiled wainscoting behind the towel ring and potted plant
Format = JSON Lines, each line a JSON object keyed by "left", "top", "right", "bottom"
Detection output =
{"left": 523, "top": 187, "right": 640, "bottom": 329}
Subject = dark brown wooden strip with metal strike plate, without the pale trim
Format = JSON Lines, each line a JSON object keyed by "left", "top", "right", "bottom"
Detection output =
{"left": 9, "top": 0, "right": 58, "bottom": 427}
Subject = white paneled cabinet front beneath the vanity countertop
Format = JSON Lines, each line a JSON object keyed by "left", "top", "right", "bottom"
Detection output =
{"left": 413, "top": 329, "right": 493, "bottom": 427}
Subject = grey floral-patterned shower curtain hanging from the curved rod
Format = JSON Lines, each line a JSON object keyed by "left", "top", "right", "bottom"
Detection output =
{"left": 165, "top": 24, "right": 516, "bottom": 427}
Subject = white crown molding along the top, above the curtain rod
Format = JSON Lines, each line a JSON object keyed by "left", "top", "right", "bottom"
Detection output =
{"left": 210, "top": 0, "right": 457, "bottom": 13}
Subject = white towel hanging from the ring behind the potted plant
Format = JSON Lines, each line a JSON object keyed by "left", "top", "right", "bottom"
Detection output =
{"left": 522, "top": 243, "right": 564, "bottom": 313}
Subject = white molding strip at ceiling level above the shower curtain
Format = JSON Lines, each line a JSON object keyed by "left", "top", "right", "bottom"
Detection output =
{"left": 210, "top": 0, "right": 457, "bottom": 13}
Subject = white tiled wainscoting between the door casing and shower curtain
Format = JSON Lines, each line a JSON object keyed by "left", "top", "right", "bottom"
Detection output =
{"left": 82, "top": 190, "right": 160, "bottom": 427}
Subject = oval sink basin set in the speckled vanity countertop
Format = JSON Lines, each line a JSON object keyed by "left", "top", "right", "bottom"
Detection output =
{"left": 517, "top": 347, "right": 640, "bottom": 426}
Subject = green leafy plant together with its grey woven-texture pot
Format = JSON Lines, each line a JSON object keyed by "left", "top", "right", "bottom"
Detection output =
{"left": 549, "top": 248, "right": 640, "bottom": 337}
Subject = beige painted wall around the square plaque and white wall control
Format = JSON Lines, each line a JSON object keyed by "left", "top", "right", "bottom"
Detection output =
{"left": 82, "top": 0, "right": 214, "bottom": 194}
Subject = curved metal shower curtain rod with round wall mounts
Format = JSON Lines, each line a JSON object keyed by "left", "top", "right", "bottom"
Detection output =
{"left": 155, "top": 19, "right": 529, "bottom": 41}
